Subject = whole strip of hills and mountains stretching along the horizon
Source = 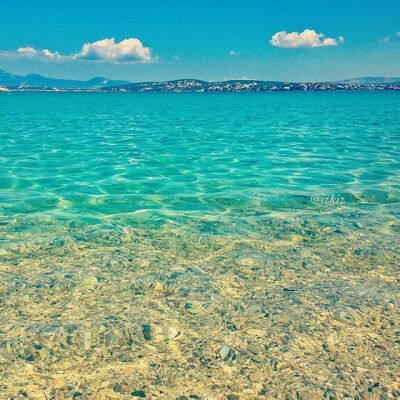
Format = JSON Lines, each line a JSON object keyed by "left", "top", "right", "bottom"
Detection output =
{"left": 0, "top": 70, "right": 400, "bottom": 91}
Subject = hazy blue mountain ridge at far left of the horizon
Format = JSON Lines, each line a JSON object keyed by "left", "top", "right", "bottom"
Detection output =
{"left": 0, "top": 70, "right": 129, "bottom": 89}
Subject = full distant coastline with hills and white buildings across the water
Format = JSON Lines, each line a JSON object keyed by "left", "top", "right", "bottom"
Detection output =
{"left": 0, "top": 70, "right": 400, "bottom": 93}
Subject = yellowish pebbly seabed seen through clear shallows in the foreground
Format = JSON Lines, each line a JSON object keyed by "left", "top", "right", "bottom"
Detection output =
{"left": 0, "top": 211, "right": 400, "bottom": 400}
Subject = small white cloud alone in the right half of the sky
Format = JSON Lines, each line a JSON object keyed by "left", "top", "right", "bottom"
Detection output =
{"left": 269, "top": 29, "right": 344, "bottom": 49}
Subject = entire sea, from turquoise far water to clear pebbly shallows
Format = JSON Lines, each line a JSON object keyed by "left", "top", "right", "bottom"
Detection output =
{"left": 0, "top": 92, "right": 400, "bottom": 399}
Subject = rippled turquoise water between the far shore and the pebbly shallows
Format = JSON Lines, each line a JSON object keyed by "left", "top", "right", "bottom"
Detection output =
{"left": 0, "top": 93, "right": 400, "bottom": 231}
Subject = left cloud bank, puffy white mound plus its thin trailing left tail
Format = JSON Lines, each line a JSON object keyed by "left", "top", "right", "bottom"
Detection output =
{"left": 0, "top": 38, "right": 152, "bottom": 63}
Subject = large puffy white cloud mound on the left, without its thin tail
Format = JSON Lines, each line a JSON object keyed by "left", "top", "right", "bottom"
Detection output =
{"left": 73, "top": 38, "right": 151, "bottom": 63}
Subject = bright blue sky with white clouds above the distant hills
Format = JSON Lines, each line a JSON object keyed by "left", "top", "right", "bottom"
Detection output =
{"left": 0, "top": 0, "right": 400, "bottom": 82}
